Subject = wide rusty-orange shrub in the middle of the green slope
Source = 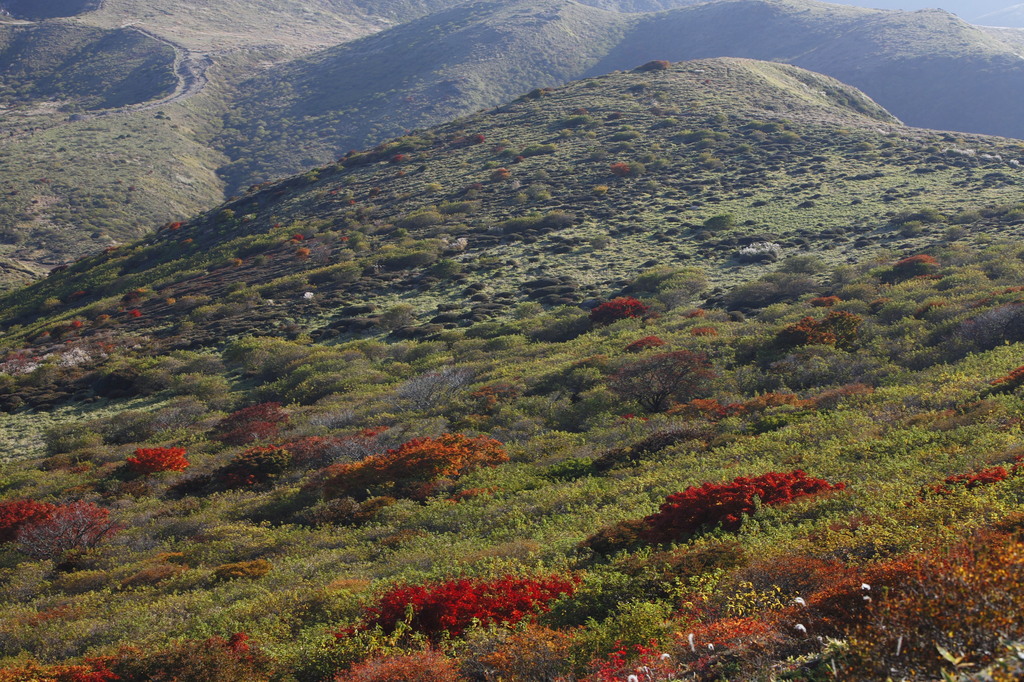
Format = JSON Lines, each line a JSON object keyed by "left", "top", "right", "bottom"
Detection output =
{"left": 324, "top": 433, "right": 508, "bottom": 499}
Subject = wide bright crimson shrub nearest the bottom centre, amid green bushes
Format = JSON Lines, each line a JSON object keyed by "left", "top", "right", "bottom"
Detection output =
{"left": 354, "top": 576, "right": 578, "bottom": 637}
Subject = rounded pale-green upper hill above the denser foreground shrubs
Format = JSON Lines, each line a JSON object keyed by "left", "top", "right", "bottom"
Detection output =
{"left": 4, "top": 59, "right": 1024, "bottom": 350}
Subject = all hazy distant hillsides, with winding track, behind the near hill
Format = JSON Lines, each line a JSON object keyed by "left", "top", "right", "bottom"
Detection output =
{"left": 6, "top": 0, "right": 1024, "bottom": 288}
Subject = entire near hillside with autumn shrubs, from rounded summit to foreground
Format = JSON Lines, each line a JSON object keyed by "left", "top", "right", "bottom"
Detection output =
{"left": 0, "top": 59, "right": 1024, "bottom": 682}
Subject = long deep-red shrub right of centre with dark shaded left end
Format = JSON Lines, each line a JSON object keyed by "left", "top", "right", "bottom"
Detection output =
{"left": 644, "top": 469, "right": 846, "bottom": 543}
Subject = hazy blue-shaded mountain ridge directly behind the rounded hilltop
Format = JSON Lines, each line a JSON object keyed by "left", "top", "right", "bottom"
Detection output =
{"left": 221, "top": 0, "right": 1024, "bottom": 193}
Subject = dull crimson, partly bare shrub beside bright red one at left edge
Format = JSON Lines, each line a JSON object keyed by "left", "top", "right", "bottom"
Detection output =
{"left": 17, "top": 502, "right": 121, "bottom": 559}
